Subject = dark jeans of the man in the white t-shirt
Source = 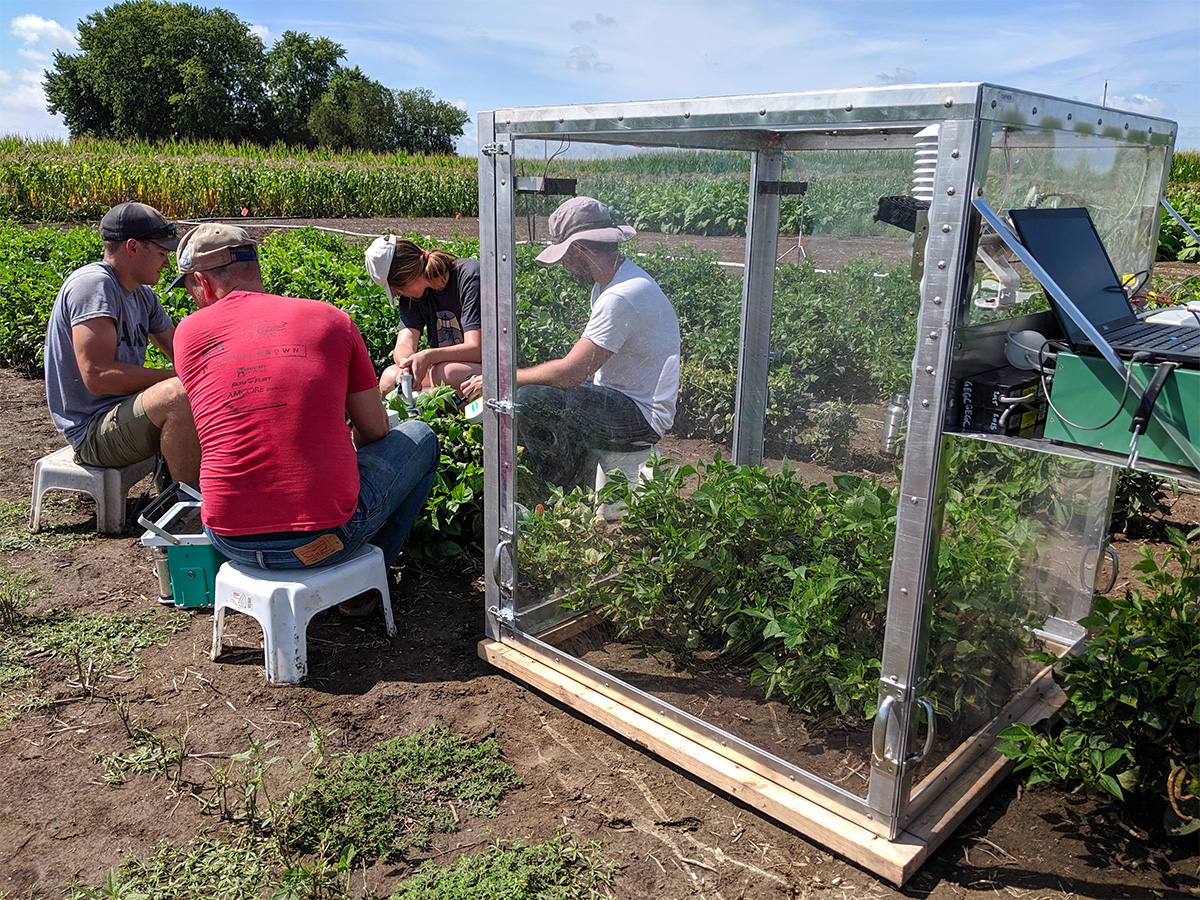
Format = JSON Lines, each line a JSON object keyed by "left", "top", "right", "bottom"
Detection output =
{"left": 516, "top": 383, "right": 661, "bottom": 487}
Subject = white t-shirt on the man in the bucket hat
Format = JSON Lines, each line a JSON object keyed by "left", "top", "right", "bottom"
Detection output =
{"left": 583, "top": 259, "right": 679, "bottom": 434}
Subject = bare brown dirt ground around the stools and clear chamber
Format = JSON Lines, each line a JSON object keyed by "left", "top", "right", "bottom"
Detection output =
{"left": 7, "top": 220, "right": 1200, "bottom": 900}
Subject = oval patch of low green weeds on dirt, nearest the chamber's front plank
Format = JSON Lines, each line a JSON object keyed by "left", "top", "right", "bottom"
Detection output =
{"left": 287, "top": 725, "right": 521, "bottom": 860}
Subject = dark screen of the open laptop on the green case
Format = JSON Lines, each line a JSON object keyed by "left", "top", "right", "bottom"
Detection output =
{"left": 1008, "top": 209, "right": 1134, "bottom": 346}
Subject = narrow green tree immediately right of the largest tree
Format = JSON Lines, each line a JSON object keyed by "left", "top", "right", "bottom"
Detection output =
{"left": 266, "top": 31, "right": 346, "bottom": 145}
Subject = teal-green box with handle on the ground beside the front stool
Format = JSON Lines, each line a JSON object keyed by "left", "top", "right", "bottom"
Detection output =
{"left": 138, "top": 482, "right": 226, "bottom": 608}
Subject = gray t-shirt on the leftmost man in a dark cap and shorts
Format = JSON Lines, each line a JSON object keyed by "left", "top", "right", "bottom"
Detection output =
{"left": 46, "top": 263, "right": 173, "bottom": 446}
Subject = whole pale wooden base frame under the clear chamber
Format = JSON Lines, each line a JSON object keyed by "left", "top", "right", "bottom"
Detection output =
{"left": 479, "top": 640, "right": 1063, "bottom": 887}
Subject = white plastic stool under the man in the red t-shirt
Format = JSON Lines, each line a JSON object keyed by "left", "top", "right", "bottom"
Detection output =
{"left": 210, "top": 544, "right": 396, "bottom": 684}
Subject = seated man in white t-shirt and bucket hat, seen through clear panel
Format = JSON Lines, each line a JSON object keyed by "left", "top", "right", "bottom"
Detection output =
{"left": 464, "top": 197, "right": 679, "bottom": 487}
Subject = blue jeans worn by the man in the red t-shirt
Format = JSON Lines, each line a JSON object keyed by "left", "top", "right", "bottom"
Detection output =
{"left": 204, "top": 420, "right": 440, "bottom": 569}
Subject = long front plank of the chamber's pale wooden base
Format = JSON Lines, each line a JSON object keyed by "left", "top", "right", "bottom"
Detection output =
{"left": 478, "top": 638, "right": 926, "bottom": 887}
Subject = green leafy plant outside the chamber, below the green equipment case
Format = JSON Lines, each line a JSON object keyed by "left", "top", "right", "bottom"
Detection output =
{"left": 1001, "top": 527, "right": 1200, "bottom": 832}
